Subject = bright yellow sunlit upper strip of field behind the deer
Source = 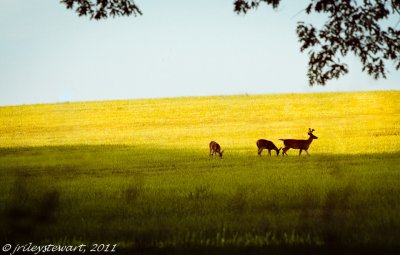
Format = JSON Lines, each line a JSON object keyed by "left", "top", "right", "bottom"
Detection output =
{"left": 0, "top": 91, "right": 400, "bottom": 154}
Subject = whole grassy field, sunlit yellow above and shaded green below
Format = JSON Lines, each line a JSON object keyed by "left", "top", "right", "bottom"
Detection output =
{"left": 0, "top": 91, "right": 400, "bottom": 254}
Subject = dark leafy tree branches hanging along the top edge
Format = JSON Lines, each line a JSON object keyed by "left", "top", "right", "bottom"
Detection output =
{"left": 61, "top": 0, "right": 400, "bottom": 85}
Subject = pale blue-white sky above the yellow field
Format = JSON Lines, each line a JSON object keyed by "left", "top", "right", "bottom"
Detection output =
{"left": 0, "top": 0, "right": 400, "bottom": 106}
